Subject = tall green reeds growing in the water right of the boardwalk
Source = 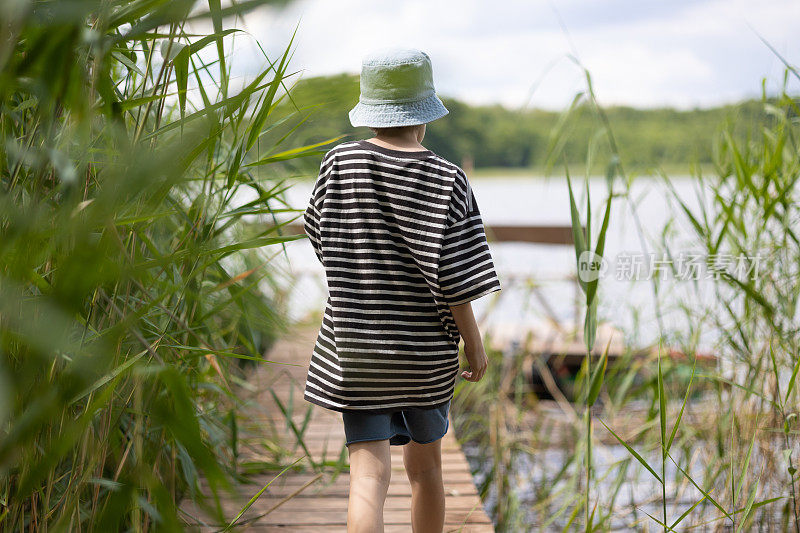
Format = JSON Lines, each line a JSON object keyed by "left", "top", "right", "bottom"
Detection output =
{"left": 540, "top": 61, "right": 799, "bottom": 531}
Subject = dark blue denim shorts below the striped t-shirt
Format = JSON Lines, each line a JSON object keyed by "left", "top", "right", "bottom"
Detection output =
{"left": 342, "top": 400, "right": 450, "bottom": 446}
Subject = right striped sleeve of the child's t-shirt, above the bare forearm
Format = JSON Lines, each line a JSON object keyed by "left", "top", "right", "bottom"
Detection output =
{"left": 438, "top": 171, "right": 501, "bottom": 305}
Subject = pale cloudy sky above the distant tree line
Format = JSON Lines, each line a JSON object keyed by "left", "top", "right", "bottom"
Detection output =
{"left": 217, "top": 0, "right": 800, "bottom": 109}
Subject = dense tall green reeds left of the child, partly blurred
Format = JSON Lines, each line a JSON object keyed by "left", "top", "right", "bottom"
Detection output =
{"left": 0, "top": 0, "right": 332, "bottom": 531}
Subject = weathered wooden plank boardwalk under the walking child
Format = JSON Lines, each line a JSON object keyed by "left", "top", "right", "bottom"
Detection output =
{"left": 182, "top": 328, "right": 494, "bottom": 533}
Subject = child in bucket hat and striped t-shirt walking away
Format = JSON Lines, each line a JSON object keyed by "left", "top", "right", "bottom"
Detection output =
{"left": 304, "top": 48, "right": 500, "bottom": 533}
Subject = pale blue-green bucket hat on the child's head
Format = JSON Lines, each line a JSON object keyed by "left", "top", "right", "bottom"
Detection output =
{"left": 349, "top": 47, "right": 449, "bottom": 128}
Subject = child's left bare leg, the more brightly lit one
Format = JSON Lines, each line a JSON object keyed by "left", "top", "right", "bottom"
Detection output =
{"left": 347, "top": 439, "right": 392, "bottom": 533}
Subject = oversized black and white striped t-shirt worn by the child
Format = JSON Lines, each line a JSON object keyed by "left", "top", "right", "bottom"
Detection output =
{"left": 303, "top": 140, "right": 500, "bottom": 412}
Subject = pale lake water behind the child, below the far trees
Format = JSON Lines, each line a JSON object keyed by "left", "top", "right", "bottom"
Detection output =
{"left": 276, "top": 176, "right": 713, "bottom": 354}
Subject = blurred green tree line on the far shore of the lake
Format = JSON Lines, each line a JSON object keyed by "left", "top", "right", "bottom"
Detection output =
{"left": 272, "top": 74, "right": 767, "bottom": 172}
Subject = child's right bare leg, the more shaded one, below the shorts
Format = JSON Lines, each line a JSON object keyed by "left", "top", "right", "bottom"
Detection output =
{"left": 403, "top": 439, "right": 444, "bottom": 533}
